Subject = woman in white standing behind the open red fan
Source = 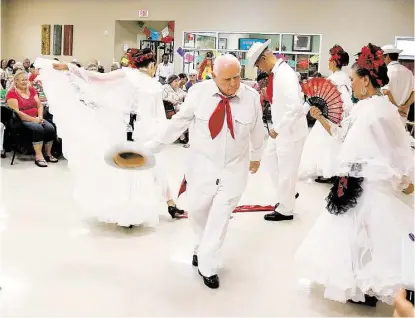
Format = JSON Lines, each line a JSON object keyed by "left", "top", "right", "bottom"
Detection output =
{"left": 299, "top": 45, "right": 353, "bottom": 183}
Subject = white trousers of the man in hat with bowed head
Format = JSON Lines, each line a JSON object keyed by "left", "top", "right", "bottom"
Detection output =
{"left": 264, "top": 137, "right": 305, "bottom": 213}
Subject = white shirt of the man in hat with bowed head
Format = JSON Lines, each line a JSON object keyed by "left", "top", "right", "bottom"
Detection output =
{"left": 271, "top": 60, "right": 308, "bottom": 141}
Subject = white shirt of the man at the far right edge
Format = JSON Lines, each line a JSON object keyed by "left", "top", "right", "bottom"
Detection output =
{"left": 384, "top": 61, "right": 414, "bottom": 106}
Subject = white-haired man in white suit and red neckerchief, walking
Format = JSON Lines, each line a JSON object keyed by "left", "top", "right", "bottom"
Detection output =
{"left": 147, "top": 55, "right": 265, "bottom": 288}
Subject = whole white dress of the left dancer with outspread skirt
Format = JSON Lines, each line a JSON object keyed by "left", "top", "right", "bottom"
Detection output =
{"left": 36, "top": 59, "right": 163, "bottom": 226}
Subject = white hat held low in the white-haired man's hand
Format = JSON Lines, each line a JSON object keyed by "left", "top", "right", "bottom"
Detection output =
{"left": 104, "top": 141, "right": 156, "bottom": 170}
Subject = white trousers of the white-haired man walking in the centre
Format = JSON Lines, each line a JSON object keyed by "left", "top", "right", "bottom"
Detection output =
{"left": 187, "top": 185, "right": 241, "bottom": 277}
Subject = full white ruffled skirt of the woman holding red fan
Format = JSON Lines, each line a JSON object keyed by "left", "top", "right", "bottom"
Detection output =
{"left": 295, "top": 182, "right": 414, "bottom": 304}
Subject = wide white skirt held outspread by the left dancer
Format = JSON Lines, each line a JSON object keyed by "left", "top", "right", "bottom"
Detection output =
{"left": 41, "top": 62, "right": 165, "bottom": 226}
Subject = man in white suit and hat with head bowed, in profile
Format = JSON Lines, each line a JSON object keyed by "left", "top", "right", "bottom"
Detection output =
{"left": 248, "top": 40, "right": 308, "bottom": 221}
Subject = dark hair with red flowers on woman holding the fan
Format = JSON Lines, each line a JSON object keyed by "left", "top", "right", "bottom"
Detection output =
{"left": 353, "top": 43, "right": 389, "bottom": 88}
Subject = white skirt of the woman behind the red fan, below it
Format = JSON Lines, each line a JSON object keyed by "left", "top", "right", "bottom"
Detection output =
{"left": 299, "top": 121, "right": 341, "bottom": 180}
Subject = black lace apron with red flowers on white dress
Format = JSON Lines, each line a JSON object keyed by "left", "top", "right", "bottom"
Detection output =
{"left": 326, "top": 177, "right": 363, "bottom": 215}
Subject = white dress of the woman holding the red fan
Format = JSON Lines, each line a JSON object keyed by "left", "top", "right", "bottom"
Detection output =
{"left": 296, "top": 96, "right": 414, "bottom": 303}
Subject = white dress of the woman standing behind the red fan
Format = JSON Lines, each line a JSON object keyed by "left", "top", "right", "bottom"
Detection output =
{"left": 299, "top": 71, "right": 353, "bottom": 180}
